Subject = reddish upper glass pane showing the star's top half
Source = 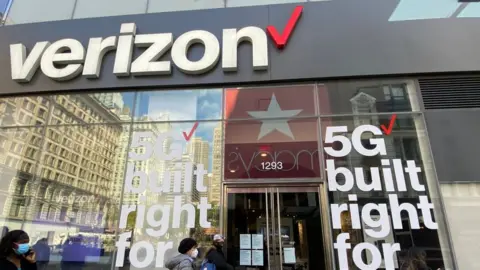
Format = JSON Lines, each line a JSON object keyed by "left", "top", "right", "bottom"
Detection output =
{"left": 225, "top": 85, "right": 316, "bottom": 119}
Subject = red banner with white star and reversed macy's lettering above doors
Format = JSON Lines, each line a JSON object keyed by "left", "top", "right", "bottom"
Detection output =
{"left": 224, "top": 85, "right": 320, "bottom": 179}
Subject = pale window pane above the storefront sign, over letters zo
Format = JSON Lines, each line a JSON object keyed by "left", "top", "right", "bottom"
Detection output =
{"left": 148, "top": 0, "right": 225, "bottom": 13}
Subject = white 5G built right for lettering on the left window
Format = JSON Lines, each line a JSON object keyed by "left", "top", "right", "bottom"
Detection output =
{"left": 114, "top": 132, "right": 212, "bottom": 269}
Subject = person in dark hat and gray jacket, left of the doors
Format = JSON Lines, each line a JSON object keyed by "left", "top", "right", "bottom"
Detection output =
{"left": 165, "top": 238, "right": 198, "bottom": 270}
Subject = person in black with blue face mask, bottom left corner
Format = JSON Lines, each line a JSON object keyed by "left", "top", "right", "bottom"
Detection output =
{"left": 0, "top": 230, "right": 37, "bottom": 270}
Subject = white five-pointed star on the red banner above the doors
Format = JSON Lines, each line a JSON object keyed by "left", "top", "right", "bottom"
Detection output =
{"left": 247, "top": 94, "right": 302, "bottom": 140}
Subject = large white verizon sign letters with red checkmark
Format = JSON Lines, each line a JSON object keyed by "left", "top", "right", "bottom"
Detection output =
{"left": 10, "top": 6, "right": 303, "bottom": 83}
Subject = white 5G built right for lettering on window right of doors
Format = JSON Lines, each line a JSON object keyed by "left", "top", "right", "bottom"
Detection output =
{"left": 324, "top": 126, "right": 438, "bottom": 270}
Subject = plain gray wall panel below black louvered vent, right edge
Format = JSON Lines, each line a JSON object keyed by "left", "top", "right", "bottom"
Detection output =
{"left": 425, "top": 109, "right": 480, "bottom": 183}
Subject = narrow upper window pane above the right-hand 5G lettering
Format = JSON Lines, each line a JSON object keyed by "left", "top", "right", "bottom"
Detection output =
{"left": 318, "top": 80, "right": 420, "bottom": 115}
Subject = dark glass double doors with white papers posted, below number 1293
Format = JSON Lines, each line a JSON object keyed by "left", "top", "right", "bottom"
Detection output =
{"left": 225, "top": 187, "right": 326, "bottom": 270}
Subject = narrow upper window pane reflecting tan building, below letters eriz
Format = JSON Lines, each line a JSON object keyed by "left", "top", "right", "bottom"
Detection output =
{"left": 50, "top": 92, "right": 135, "bottom": 125}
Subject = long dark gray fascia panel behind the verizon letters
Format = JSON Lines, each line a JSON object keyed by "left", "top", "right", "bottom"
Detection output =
{"left": 0, "top": 0, "right": 480, "bottom": 94}
